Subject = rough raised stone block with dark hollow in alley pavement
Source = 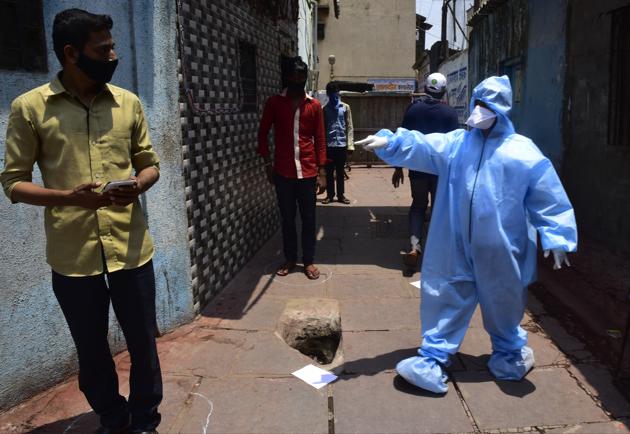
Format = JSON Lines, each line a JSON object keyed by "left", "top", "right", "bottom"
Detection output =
{"left": 278, "top": 299, "right": 341, "bottom": 365}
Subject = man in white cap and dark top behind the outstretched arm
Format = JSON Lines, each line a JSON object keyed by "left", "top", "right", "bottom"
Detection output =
{"left": 392, "top": 72, "right": 459, "bottom": 272}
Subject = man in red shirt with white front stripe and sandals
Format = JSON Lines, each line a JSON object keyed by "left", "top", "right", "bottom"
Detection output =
{"left": 258, "top": 57, "right": 326, "bottom": 279}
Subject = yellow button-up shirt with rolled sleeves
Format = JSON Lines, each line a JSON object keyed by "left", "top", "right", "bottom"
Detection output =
{"left": 0, "top": 77, "right": 159, "bottom": 276}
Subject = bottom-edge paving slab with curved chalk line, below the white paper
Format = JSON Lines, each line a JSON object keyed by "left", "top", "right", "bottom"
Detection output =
{"left": 171, "top": 378, "right": 328, "bottom": 434}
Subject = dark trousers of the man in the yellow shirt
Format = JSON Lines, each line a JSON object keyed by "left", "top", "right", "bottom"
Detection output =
{"left": 52, "top": 261, "right": 162, "bottom": 430}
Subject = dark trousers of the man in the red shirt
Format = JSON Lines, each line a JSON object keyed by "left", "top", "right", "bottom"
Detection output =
{"left": 274, "top": 174, "right": 317, "bottom": 266}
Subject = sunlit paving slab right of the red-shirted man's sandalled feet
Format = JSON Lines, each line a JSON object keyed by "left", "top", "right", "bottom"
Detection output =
{"left": 326, "top": 274, "right": 411, "bottom": 299}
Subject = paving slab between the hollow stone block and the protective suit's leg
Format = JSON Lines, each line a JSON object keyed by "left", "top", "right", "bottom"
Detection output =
{"left": 341, "top": 298, "right": 420, "bottom": 331}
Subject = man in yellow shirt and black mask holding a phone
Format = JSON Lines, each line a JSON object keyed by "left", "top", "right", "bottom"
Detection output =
{"left": 0, "top": 9, "right": 162, "bottom": 433}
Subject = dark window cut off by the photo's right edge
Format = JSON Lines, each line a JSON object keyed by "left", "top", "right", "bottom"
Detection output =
{"left": 608, "top": 6, "right": 630, "bottom": 146}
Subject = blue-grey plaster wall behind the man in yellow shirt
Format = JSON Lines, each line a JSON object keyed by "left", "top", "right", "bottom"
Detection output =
{"left": 0, "top": 0, "right": 194, "bottom": 409}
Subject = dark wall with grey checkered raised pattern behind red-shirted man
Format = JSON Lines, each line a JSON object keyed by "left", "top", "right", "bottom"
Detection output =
{"left": 179, "top": 0, "right": 297, "bottom": 309}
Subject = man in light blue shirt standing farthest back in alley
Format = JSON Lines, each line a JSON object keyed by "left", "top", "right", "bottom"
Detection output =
{"left": 322, "top": 82, "right": 354, "bottom": 205}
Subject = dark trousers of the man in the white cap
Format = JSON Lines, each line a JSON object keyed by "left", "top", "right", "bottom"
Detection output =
{"left": 409, "top": 172, "right": 437, "bottom": 251}
